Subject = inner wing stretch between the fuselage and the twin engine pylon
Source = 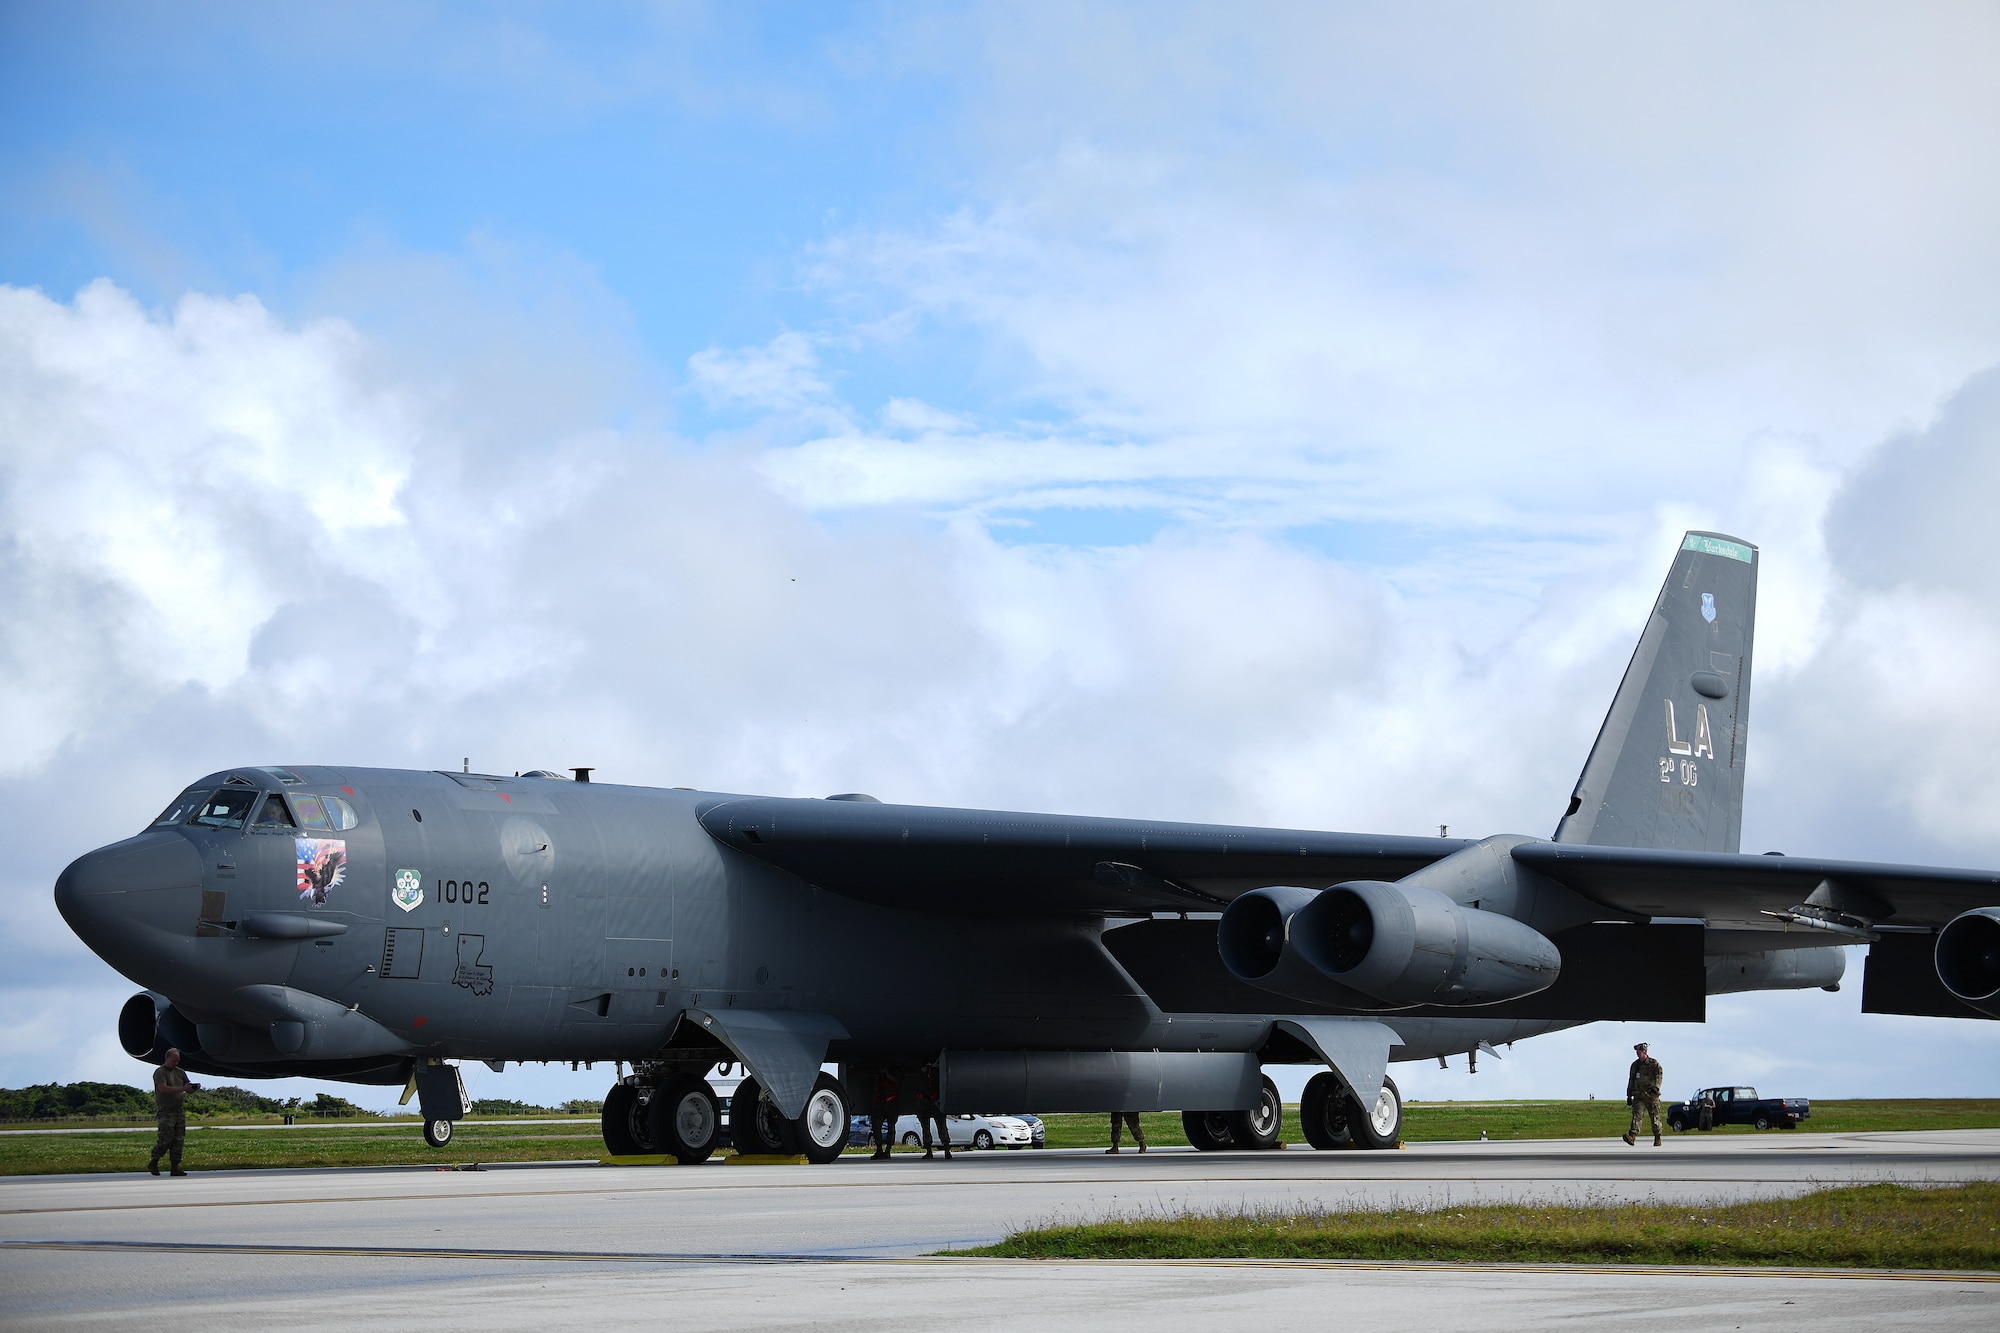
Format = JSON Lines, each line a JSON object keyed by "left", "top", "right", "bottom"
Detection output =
{"left": 700, "top": 797, "right": 1468, "bottom": 915}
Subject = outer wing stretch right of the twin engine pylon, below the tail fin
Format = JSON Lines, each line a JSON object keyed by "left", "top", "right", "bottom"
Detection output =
{"left": 1512, "top": 843, "right": 2000, "bottom": 929}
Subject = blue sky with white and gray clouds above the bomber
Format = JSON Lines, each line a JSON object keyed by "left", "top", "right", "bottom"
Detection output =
{"left": 0, "top": 4, "right": 2000, "bottom": 1095}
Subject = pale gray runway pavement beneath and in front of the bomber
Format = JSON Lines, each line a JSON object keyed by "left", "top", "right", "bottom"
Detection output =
{"left": 0, "top": 1131, "right": 2000, "bottom": 1333}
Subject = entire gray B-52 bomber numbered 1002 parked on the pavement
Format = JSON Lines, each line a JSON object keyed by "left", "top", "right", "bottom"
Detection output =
{"left": 56, "top": 532, "right": 2000, "bottom": 1163}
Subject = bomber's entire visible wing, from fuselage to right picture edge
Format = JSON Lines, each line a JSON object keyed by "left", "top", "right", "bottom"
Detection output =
{"left": 700, "top": 797, "right": 2000, "bottom": 931}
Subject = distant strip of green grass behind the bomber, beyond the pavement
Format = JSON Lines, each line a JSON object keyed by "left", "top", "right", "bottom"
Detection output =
{"left": 0, "top": 1099, "right": 2000, "bottom": 1175}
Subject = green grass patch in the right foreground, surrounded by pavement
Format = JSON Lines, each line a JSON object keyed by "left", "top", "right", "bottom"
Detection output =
{"left": 956, "top": 1181, "right": 2000, "bottom": 1269}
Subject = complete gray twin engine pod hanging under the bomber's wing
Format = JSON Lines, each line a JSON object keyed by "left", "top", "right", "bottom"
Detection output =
{"left": 1216, "top": 881, "right": 1562, "bottom": 1009}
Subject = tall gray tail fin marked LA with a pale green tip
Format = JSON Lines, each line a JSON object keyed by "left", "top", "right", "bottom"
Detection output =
{"left": 1556, "top": 532, "right": 1758, "bottom": 853}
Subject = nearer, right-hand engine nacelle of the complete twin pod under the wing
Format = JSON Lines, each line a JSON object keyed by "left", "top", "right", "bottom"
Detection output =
{"left": 1286, "top": 881, "right": 1562, "bottom": 1005}
